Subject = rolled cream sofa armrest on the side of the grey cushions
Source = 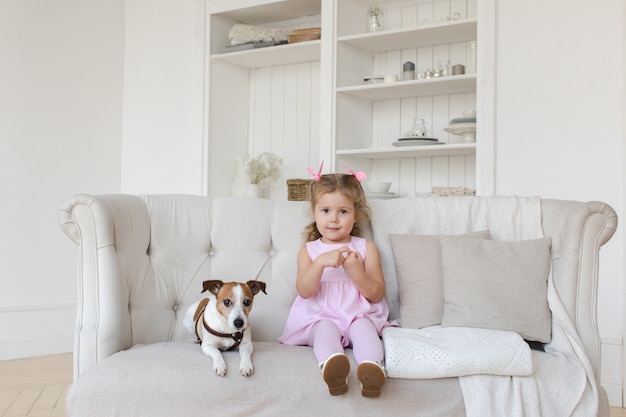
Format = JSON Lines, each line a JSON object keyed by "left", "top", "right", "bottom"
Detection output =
{"left": 541, "top": 199, "right": 617, "bottom": 382}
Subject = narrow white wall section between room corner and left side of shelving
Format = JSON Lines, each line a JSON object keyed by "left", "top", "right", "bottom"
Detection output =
{"left": 122, "top": 0, "right": 206, "bottom": 194}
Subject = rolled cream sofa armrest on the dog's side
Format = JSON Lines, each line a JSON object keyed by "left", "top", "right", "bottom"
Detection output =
{"left": 59, "top": 194, "right": 150, "bottom": 378}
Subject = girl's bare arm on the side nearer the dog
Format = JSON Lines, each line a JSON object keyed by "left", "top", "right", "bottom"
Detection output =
{"left": 296, "top": 246, "right": 354, "bottom": 298}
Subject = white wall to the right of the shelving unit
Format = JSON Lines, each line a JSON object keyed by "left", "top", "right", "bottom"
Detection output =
{"left": 495, "top": 0, "right": 626, "bottom": 405}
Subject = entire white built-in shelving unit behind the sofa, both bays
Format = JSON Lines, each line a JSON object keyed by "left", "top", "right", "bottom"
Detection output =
{"left": 205, "top": 0, "right": 495, "bottom": 199}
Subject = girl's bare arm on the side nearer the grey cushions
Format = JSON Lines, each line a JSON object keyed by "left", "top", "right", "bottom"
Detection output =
{"left": 343, "top": 240, "right": 385, "bottom": 303}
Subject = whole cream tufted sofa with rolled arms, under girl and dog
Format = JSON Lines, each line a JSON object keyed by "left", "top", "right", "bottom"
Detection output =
{"left": 59, "top": 194, "right": 617, "bottom": 417}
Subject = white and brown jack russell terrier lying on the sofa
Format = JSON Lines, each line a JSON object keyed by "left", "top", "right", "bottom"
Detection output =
{"left": 183, "top": 280, "right": 267, "bottom": 376}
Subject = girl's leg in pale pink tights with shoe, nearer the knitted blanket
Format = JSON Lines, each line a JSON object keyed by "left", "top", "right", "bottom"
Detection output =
{"left": 348, "top": 319, "right": 386, "bottom": 398}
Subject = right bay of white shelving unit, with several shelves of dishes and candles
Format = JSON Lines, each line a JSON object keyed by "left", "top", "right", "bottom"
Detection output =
{"left": 334, "top": 0, "right": 479, "bottom": 195}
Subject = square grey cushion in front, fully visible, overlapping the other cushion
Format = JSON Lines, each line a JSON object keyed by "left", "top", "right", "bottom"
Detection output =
{"left": 441, "top": 237, "right": 552, "bottom": 343}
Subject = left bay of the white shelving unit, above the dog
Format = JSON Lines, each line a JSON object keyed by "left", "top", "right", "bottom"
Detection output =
{"left": 205, "top": 0, "right": 322, "bottom": 199}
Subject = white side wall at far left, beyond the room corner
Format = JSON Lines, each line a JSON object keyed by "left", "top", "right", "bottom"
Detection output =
{"left": 0, "top": 0, "right": 123, "bottom": 360}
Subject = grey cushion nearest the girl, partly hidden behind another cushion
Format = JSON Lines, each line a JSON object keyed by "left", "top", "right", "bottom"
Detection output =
{"left": 389, "top": 230, "right": 489, "bottom": 329}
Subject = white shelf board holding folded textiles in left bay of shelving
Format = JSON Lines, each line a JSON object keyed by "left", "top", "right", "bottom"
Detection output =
{"left": 211, "top": 40, "right": 321, "bottom": 68}
